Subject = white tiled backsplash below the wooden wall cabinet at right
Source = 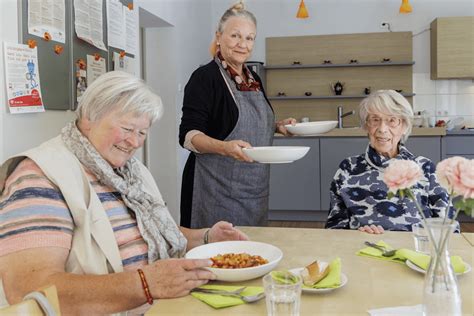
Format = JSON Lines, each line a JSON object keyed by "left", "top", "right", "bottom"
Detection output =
{"left": 413, "top": 73, "right": 474, "bottom": 127}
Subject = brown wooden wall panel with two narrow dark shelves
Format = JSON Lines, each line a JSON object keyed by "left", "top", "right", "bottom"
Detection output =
{"left": 265, "top": 32, "right": 414, "bottom": 126}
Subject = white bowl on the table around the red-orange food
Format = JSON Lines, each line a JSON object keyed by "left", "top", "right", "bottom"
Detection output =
{"left": 186, "top": 241, "right": 283, "bottom": 282}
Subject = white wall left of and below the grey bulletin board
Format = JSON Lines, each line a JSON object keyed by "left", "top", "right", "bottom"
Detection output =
{"left": 0, "top": 0, "right": 74, "bottom": 161}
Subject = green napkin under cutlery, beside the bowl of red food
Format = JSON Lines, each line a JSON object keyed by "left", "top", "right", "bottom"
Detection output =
{"left": 191, "top": 284, "right": 263, "bottom": 308}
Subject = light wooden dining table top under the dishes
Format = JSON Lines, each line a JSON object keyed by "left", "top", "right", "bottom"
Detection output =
{"left": 147, "top": 227, "right": 474, "bottom": 316}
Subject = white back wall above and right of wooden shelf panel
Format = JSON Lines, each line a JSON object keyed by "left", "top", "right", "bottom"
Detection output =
{"left": 212, "top": 0, "right": 474, "bottom": 127}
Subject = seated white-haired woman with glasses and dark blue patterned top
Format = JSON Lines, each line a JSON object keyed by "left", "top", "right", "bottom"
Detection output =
{"left": 326, "top": 90, "right": 452, "bottom": 234}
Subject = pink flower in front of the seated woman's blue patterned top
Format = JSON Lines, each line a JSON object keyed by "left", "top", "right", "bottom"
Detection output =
{"left": 383, "top": 159, "right": 423, "bottom": 193}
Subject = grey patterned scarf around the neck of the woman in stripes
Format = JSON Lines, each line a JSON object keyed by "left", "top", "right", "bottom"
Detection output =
{"left": 61, "top": 121, "right": 187, "bottom": 263}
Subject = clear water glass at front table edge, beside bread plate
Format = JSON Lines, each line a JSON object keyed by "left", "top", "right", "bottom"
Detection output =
{"left": 263, "top": 271, "right": 302, "bottom": 316}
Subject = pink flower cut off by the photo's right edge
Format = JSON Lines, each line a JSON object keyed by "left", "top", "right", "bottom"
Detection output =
{"left": 436, "top": 156, "right": 474, "bottom": 199}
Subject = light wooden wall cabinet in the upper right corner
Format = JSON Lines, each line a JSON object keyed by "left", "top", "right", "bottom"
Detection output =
{"left": 430, "top": 16, "right": 474, "bottom": 80}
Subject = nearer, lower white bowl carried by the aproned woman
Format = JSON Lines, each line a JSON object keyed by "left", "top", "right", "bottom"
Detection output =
{"left": 242, "top": 146, "right": 309, "bottom": 163}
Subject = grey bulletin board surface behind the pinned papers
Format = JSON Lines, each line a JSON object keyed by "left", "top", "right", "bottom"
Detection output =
{"left": 21, "top": 0, "right": 134, "bottom": 110}
